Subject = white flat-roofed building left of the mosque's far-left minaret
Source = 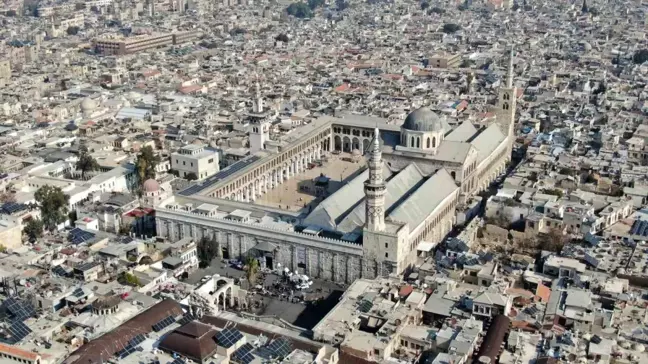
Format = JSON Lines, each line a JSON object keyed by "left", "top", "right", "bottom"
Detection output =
{"left": 171, "top": 145, "right": 219, "bottom": 180}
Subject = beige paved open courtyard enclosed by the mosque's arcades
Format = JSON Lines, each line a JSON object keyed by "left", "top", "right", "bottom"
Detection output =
{"left": 255, "top": 153, "right": 366, "bottom": 211}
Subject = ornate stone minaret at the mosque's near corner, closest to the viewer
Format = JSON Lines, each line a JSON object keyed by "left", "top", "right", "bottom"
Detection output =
{"left": 365, "top": 128, "right": 385, "bottom": 231}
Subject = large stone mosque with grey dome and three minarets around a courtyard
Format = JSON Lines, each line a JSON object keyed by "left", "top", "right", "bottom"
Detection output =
{"left": 156, "top": 54, "right": 517, "bottom": 282}
